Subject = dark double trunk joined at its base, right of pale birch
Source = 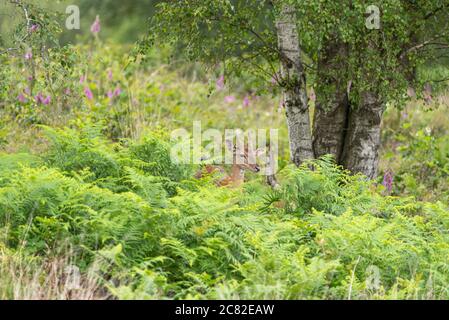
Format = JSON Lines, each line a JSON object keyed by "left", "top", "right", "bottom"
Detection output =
{"left": 313, "top": 40, "right": 384, "bottom": 179}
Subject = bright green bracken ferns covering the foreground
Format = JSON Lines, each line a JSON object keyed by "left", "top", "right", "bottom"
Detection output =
{"left": 0, "top": 128, "right": 449, "bottom": 299}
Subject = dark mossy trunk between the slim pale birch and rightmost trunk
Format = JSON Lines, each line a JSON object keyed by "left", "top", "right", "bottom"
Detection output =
{"left": 313, "top": 41, "right": 349, "bottom": 163}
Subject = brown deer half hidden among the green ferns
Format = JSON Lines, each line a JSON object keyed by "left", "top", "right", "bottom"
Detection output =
{"left": 195, "top": 141, "right": 264, "bottom": 188}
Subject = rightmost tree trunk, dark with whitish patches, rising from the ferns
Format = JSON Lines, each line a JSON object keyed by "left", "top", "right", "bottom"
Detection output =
{"left": 342, "top": 92, "right": 384, "bottom": 179}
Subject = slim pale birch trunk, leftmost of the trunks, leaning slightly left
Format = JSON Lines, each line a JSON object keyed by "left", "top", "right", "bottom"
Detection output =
{"left": 276, "top": 5, "right": 315, "bottom": 166}
